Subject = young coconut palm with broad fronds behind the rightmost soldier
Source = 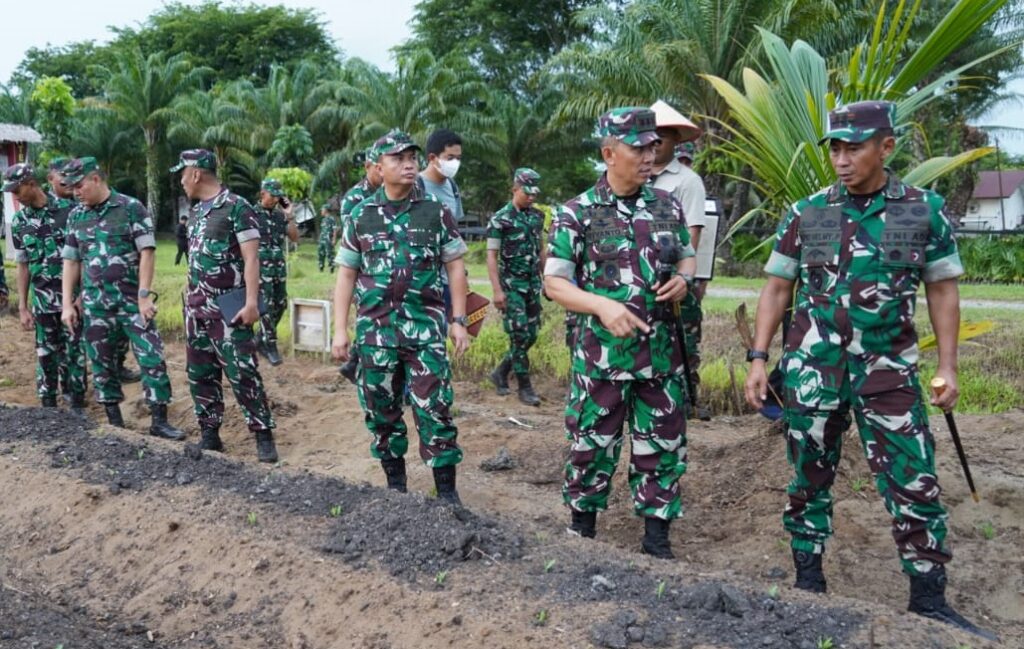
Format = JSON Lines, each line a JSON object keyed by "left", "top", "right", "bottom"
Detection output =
{"left": 705, "top": 0, "right": 1006, "bottom": 229}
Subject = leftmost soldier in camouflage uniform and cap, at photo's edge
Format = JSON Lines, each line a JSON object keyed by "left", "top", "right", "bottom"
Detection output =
{"left": 3, "top": 163, "right": 86, "bottom": 414}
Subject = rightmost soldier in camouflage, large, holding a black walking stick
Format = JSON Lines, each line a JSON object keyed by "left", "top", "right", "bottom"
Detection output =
{"left": 746, "top": 101, "right": 984, "bottom": 634}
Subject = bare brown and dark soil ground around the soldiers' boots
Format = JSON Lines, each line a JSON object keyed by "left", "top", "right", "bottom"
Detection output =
{"left": 0, "top": 317, "right": 1024, "bottom": 649}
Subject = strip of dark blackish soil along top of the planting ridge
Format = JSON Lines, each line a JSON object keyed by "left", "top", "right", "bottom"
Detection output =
{"left": 0, "top": 408, "right": 862, "bottom": 649}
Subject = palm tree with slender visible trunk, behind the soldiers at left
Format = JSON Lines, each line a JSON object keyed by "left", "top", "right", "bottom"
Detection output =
{"left": 95, "top": 48, "right": 212, "bottom": 222}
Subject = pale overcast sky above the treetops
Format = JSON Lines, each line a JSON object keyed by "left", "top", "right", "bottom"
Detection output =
{"left": 0, "top": 0, "right": 1024, "bottom": 155}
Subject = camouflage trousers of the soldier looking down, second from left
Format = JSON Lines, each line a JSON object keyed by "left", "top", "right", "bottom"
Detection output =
{"left": 84, "top": 305, "right": 171, "bottom": 403}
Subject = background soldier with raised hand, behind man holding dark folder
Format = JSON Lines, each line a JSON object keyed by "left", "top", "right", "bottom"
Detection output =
{"left": 254, "top": 178, "right": 299, "bottom": 365}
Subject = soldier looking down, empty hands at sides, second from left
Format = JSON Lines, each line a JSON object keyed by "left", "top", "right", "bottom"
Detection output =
{"left": 60, "top": 158, "right": 185, "bottom": 439}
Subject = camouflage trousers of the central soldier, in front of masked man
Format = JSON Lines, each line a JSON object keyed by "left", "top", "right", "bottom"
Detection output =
{"left": 358, "top": 342, "right": 462, "bottom": 468}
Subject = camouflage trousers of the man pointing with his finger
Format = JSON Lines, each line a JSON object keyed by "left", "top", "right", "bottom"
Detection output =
{"left": 562, "top": 373, "right": 686, "bottom": 520}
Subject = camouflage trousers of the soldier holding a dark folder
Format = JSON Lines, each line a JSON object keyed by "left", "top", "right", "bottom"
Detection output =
{"left": 185, "top": 310, "right": 274, "bottom": 432}
